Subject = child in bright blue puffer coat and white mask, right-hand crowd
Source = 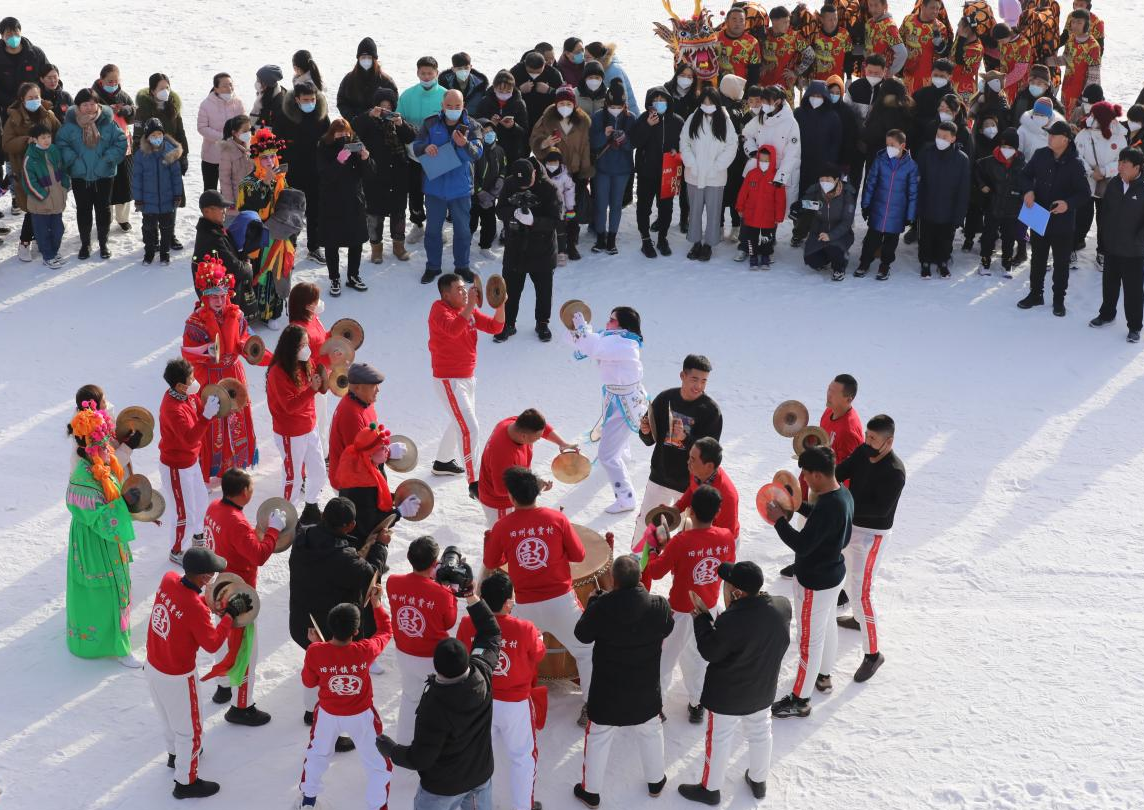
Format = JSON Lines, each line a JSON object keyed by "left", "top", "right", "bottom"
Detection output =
{"left": 855, "top": 129, "right": 917, "bottom": 281}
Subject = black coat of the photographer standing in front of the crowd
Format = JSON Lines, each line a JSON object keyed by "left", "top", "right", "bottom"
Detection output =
{"left": 496, "top": 168, "right": 564, "bottom": 272}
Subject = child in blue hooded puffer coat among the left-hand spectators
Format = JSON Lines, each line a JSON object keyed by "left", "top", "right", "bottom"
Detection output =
{"left": 132, "top": 118, "right": 183, "bottom": 265}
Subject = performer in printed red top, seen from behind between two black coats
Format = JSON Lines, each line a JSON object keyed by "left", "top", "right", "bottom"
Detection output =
{"left": 643, "top": 485, "right": 737, "bottom": 723}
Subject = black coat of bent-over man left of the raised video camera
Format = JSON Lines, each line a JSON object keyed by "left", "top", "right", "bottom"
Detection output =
{"left": 289, "top": 523, "right": 378, "bottom": 650}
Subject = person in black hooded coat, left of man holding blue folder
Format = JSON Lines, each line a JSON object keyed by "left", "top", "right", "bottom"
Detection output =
{"left": 975, "top": 127, "right": 1025, "bottom": 278}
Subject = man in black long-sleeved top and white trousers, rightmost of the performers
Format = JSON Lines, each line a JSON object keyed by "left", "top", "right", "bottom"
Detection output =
{"left": 834, "top": 413, "right": 906, "bottom": 683}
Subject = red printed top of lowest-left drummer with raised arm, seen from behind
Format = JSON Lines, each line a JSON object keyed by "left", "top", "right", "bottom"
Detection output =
{"left": 302, "top": 605, "right": 394, "bottom": 717}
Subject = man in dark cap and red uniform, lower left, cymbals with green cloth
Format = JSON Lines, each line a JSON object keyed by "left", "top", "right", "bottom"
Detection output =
{"left": 144, "top": 546, "right": 241, "bottom": 799}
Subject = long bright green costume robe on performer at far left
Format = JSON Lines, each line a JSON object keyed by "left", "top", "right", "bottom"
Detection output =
{"left": 65, "top": 460, "right": 135, "bottom": 658}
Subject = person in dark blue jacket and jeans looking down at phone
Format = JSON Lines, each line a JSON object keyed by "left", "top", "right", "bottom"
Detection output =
{"left": 588, "top": 79, "right": 636, "bottom": 256}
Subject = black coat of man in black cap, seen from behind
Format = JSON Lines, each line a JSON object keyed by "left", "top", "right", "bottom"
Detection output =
{"left": 692, "top": 594, "right": 791, "bottom": 717}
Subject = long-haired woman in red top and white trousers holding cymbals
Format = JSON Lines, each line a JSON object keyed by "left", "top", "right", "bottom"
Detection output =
{"left": 267, "top": 324, "right": 326, "bottom": 525}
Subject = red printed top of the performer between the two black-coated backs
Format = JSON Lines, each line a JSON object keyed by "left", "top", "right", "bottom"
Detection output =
{"left": 643, "top": 526, "right": 734, "bottom": 613}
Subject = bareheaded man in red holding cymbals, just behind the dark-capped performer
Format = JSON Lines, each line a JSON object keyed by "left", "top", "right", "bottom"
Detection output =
{"left": 202, "top": 470, "right": 286, "bottom": 725}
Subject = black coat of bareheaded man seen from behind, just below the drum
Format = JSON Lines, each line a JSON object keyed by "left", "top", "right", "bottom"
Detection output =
{"left": 575, "top": 585, "right": 675, "bottom": 725}
